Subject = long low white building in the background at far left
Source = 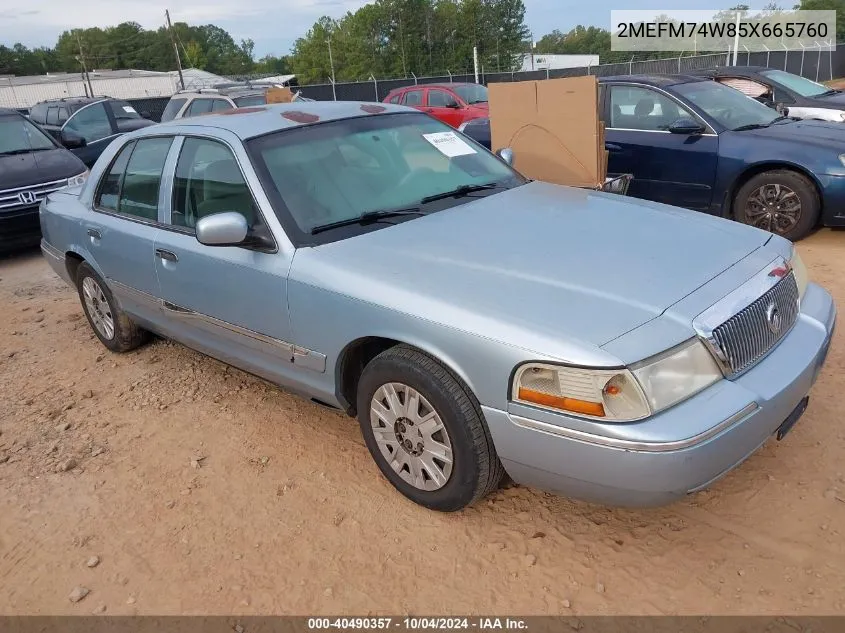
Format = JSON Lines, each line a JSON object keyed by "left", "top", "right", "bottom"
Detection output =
{"left": 0, "top": 68, "right": 227, "bottom": 108}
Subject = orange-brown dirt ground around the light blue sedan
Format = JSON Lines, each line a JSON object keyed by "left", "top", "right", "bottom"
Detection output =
{"left": 0, "top": 231, "right": 845, "bottom": 615}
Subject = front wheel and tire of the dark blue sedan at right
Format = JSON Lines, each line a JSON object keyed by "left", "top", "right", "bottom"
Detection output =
{"left": 733, "top": 169, "right": 821, "bottom": 241}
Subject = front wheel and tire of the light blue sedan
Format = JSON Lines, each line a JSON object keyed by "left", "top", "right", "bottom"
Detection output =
{"left": 357, "top": 345, "right": 504, "bottom": 512}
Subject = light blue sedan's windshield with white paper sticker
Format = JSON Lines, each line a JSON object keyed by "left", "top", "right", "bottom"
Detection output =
{"left": 248, "top": 113, "right": 525, "bottom": 244}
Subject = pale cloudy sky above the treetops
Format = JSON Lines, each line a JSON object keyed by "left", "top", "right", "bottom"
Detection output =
{"left": 0, "top": 0, "right": 740, "bottom": 58}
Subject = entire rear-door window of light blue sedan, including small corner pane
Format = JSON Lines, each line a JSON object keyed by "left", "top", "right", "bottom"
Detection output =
{"left": 97, "top": 137, "right": 173, "bottom": 222}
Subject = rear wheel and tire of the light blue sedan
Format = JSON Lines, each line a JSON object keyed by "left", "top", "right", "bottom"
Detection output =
{"left": 76, "top": 262, "right": 149, "bottom": 352}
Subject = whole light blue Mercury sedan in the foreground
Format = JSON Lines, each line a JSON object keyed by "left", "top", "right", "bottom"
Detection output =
{"left": 36, "top": 102, "right": 835, "bottom": 511}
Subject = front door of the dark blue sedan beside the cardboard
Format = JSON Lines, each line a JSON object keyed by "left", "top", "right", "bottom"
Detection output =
{"left": 605, "top": 84, "right": 719, "bottom": 210}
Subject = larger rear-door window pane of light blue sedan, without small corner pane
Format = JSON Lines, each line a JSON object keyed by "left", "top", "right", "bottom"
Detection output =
{"left": 107, "top": 137, "right": 173, "bottom": 222}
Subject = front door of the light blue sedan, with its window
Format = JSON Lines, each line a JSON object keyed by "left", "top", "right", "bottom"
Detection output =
{"left": 155, "top": 137, "right": 296, "bottom": 382}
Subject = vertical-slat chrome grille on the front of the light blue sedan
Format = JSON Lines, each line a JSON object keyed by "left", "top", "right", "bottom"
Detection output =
{"left": 712, "top": 272, "right": 798, "bottom": 377}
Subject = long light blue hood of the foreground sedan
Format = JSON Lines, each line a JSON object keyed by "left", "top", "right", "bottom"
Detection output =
{"left": 298, "top": 182, "right": 771, "bottom": 354}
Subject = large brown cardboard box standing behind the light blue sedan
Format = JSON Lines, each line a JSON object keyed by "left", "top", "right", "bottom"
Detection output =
{"left": 488, "top": 76, "right": 607, "bottom": 187}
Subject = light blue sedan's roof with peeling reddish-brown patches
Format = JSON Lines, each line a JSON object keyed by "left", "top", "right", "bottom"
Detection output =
{"left": 151, "top": 101, "right": 418, "bottom": 140}
